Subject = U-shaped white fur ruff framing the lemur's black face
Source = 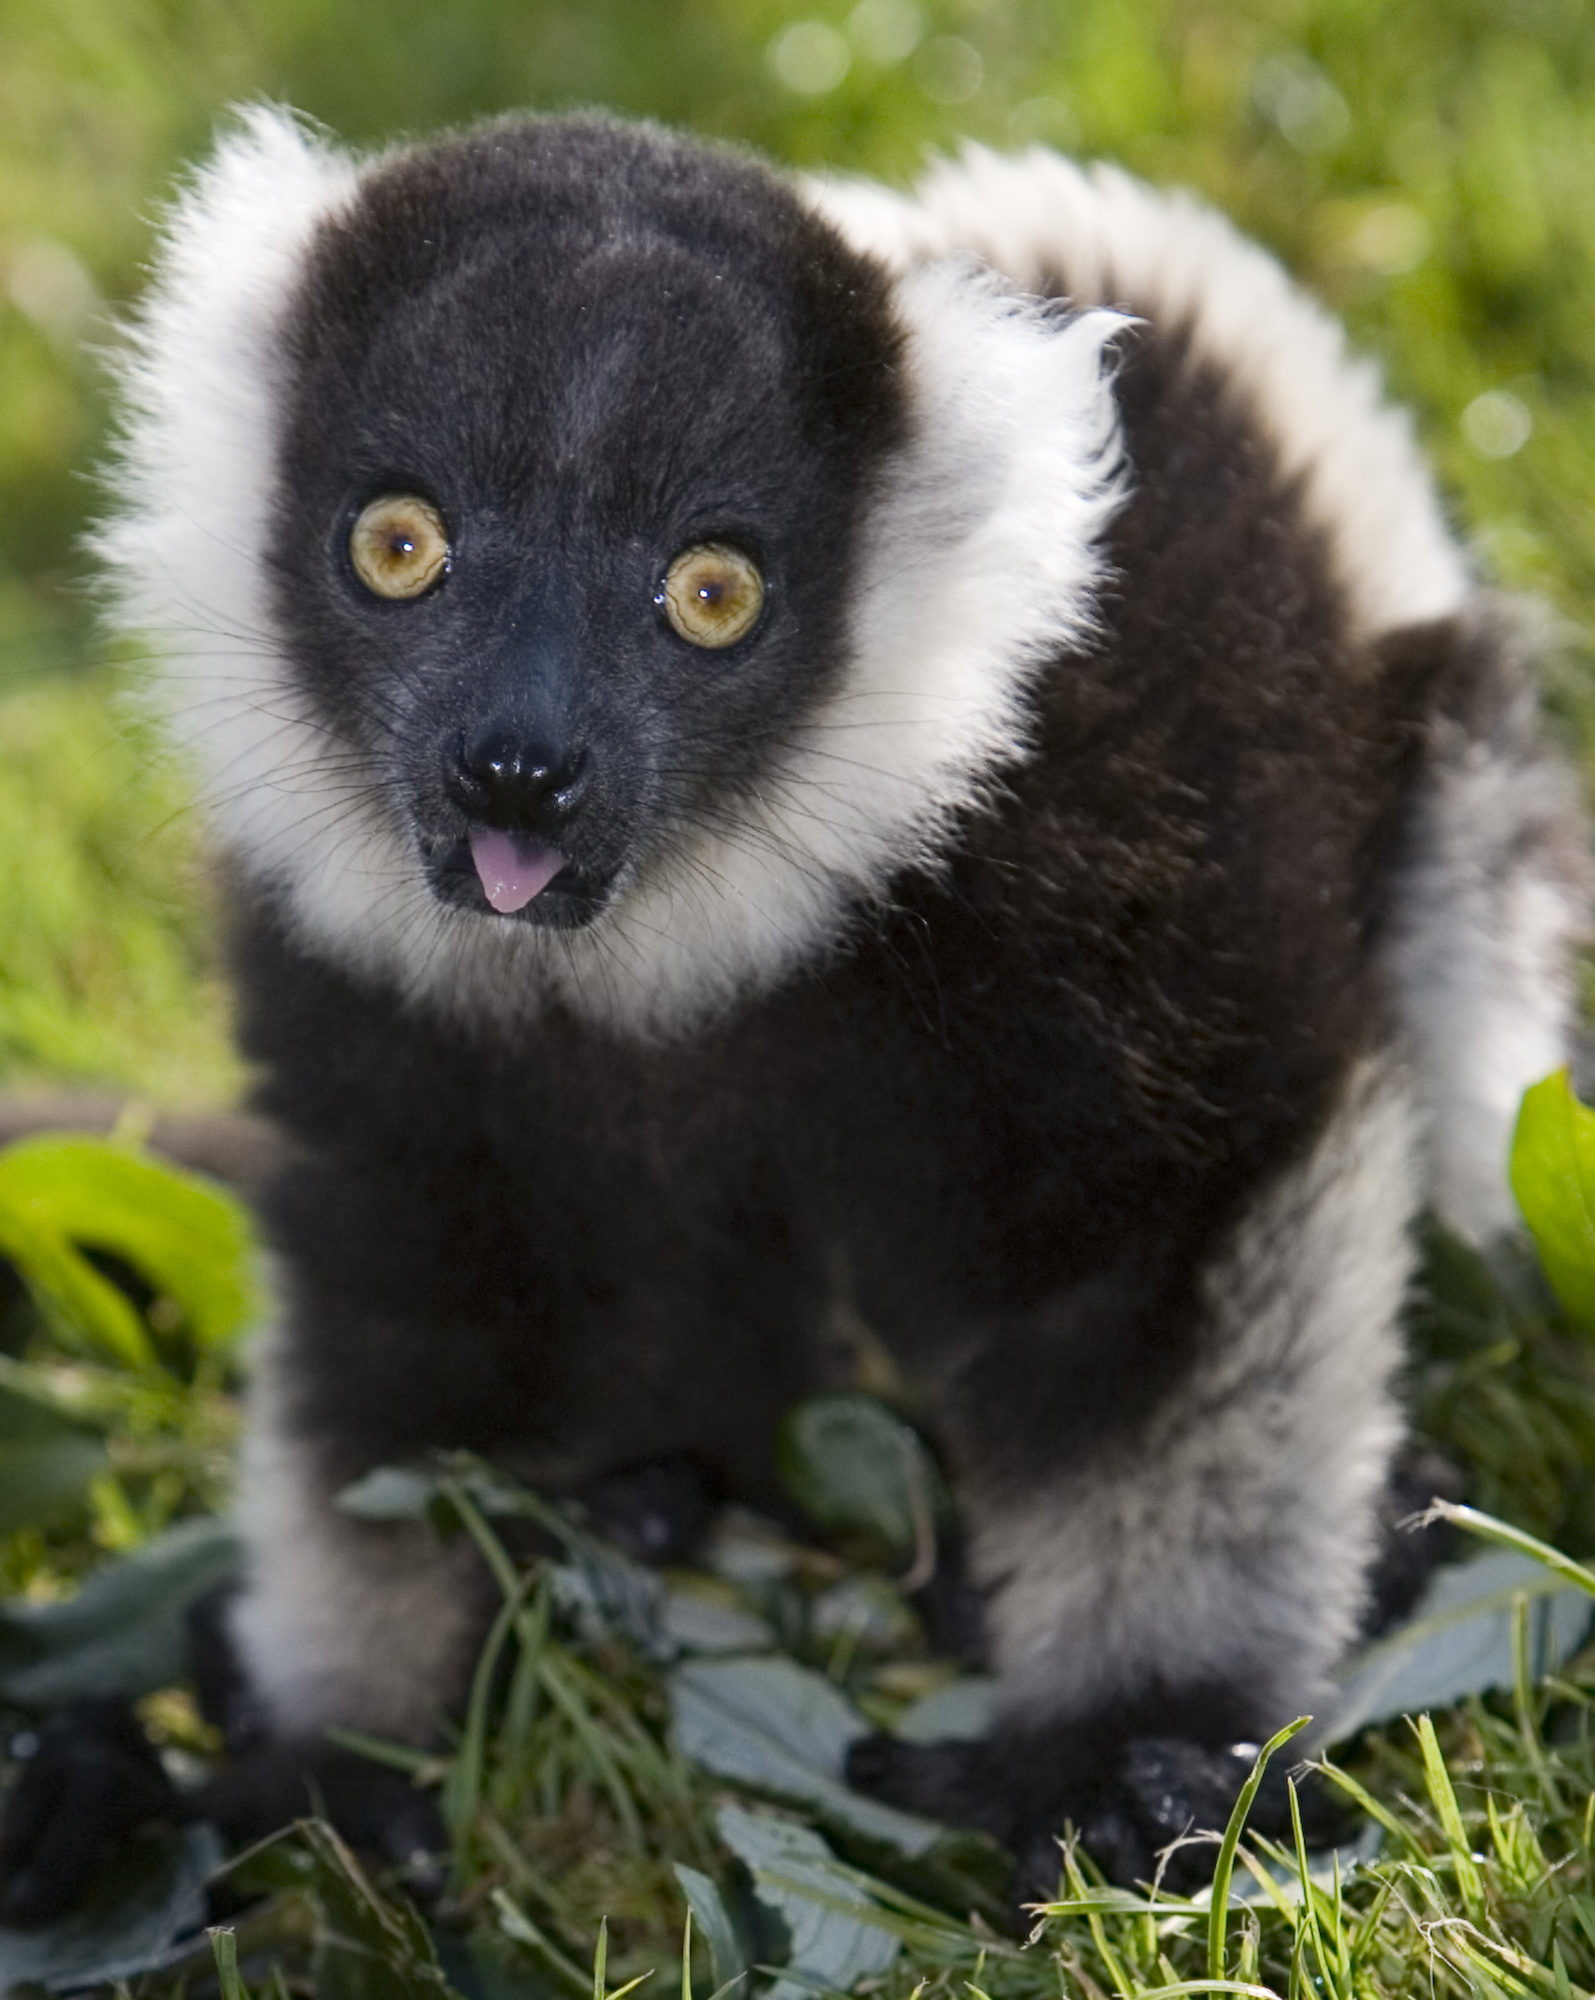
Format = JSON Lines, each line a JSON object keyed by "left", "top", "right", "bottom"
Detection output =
{"left": 102, "top": 110, "right": 1121, "bottom": 1032}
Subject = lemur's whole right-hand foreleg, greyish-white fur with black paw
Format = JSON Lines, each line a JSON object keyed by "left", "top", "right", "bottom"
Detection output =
{"left": 849, "top": 1062, "right": 1419, "bottom": 1890}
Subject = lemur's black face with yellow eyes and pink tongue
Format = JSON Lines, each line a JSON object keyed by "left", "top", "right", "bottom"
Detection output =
{"left": 270, "top": 132, "right": 901, "bottom": 928}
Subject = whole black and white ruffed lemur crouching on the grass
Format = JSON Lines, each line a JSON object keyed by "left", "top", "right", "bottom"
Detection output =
{"left": 6, "top": 112, "right": 1587, "bottom": 1908}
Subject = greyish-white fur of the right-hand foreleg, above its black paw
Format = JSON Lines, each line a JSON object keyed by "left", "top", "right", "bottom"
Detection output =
{"left": 973, "top": 1064, "right": 1419, "bottom": 1728}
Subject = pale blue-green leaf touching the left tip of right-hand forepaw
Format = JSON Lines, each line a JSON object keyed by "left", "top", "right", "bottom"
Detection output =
{"left": 670, "top": 1656, "right": 941, "bottom": 1856}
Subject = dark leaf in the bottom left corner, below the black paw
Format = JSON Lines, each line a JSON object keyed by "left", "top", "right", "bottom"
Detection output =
{"left": 0, "top": 1826, "right": 222, "bottom": 1992}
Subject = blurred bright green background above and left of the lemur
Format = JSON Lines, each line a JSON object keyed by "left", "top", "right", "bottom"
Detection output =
{"left": 0, "top": 0, "right": 1595, "bottom": 1102}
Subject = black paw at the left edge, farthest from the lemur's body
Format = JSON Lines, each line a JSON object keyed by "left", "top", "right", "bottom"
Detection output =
{"left": 0, "top": 1698, "right": 184, "bottom": 1924}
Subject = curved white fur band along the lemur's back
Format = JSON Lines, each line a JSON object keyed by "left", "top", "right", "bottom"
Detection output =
{"left": 811, "top": 146, "right": 1469, "bottom": 636}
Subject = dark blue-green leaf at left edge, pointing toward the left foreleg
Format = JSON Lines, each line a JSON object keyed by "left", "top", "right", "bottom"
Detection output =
{"left": 0, "top": 1520, "right": 240, "bottom": 1708}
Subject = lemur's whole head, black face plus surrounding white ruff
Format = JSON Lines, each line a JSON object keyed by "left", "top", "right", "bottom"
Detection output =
{"left": 104, "top": 114, "right": 1113, "bottom": 1026}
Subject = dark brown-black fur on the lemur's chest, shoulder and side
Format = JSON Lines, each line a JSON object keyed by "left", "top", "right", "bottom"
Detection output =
{"left": 242, "top": 254, "right": 1427, "bottom": 1498}
